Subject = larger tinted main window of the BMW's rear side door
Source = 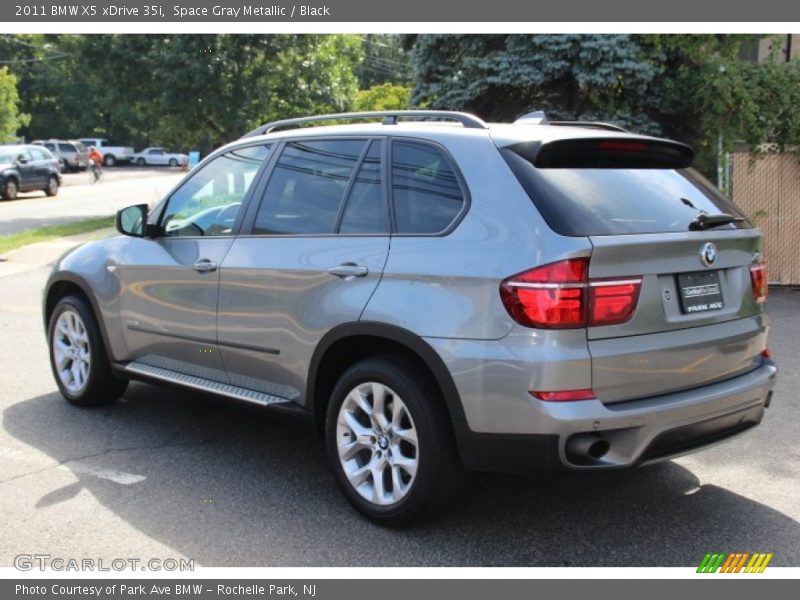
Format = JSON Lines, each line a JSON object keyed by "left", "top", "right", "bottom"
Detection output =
{"left": 253, "top": 140, "right": 366, "bottom": 235}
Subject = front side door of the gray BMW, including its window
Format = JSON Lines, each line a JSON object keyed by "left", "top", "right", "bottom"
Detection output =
{"left": 118, "top": 145, "right": 269, "bottom": 382}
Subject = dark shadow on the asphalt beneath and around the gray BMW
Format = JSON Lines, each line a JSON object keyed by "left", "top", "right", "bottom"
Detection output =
{"left": 3, "top": 383, "right": 800, "bottom": 567}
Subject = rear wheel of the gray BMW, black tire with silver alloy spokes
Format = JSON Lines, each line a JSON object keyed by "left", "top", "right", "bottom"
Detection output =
{"left": 325, "top": 355, "right": 463, "bottom": 527}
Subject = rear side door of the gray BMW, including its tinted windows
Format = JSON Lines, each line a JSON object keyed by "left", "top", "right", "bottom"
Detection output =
{"left": 218, "top": 138, "right": 390, "bottom": 401}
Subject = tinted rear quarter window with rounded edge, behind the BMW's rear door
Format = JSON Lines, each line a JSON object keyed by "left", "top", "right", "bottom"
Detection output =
{"left": 392, "top": 141, "right": 464, "bottom": 233}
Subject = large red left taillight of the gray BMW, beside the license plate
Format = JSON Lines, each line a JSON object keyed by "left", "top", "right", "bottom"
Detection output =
{"left": 500, "top": 258, "right": 642, "bottom": 329}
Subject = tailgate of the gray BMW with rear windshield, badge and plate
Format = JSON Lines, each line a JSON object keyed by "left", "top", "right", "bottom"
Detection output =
{"left": 503, "top": 139, "right": 767, "bottom": 403}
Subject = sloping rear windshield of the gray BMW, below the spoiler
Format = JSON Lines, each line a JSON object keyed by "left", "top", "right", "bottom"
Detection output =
{"left": 500, "top": 148, "right": 752, "bottom": 236}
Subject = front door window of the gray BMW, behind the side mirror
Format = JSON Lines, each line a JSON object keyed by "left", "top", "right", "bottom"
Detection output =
{"left": 161, "top": 146, "right": 269, "bottom": 236}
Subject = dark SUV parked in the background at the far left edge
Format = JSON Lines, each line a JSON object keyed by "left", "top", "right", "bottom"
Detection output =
{"left": 0, "top": 144, "right": 61, "bottom": 200}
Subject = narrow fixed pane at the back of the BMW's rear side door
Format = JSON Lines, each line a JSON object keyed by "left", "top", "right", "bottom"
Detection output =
{"left": 339, "top": 141, "right": 387, "bottom": 233}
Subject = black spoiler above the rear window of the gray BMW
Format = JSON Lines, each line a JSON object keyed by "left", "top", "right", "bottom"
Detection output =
{"left": 507, "top": 137, "right": 694, "bottom": 169}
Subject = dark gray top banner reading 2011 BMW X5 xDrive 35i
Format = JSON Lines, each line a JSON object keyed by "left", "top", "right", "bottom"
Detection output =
{"left": 0, "top": 0, "right": 800, "bottom": 24}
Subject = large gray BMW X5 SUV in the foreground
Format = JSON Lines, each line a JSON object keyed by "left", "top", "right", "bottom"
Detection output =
{"left": 44, "top": 111, "right": 776, "bottom": 525}
